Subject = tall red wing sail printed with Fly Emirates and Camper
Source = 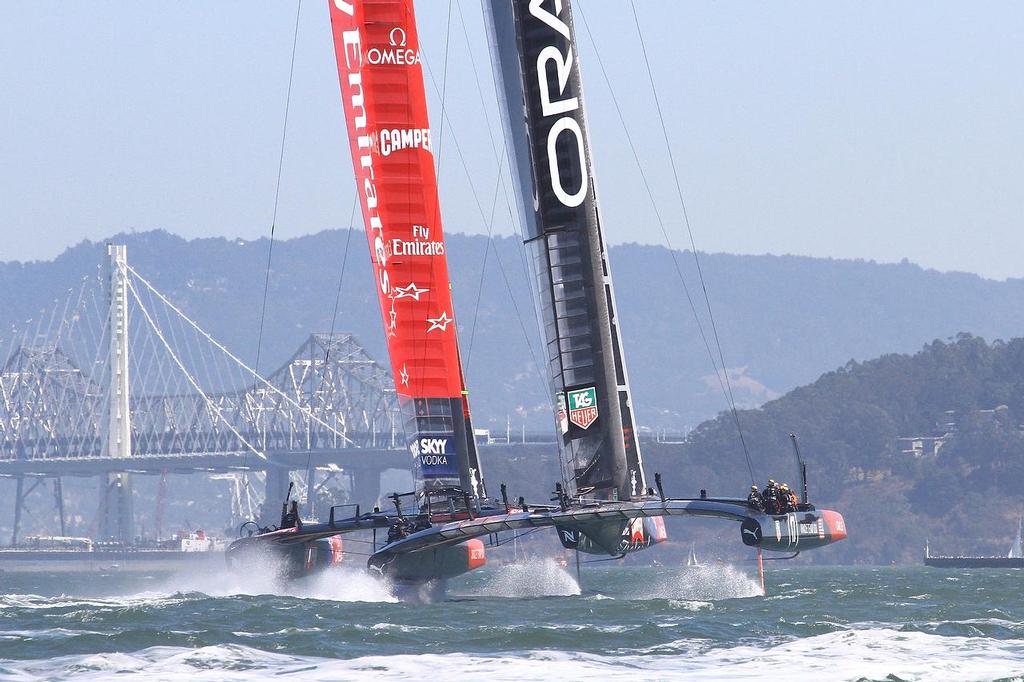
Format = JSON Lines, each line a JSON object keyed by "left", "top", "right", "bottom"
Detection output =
{"left": 329, "top": 0, "right": 485, "bottom": 499}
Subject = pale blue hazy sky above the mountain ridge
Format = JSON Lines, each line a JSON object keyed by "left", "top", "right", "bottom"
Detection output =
{"left": 0, "top": 0, "right": 1024, "bottom": 278}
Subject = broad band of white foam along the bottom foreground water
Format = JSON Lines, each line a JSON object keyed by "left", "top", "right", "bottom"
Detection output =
{"left": 0, "top": 629, "right": 1024, "bottom": 682}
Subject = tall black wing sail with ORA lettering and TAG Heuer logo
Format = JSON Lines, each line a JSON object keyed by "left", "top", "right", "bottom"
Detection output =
{"left": 483, "top": 0, "right": 646, "bottom": 500}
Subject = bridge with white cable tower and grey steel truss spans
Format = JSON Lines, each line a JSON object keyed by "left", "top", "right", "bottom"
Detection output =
{"left": 0, "top": 245, "right": 410, "bottom": 545}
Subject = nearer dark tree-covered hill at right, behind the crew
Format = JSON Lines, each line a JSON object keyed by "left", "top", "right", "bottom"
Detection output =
{"left": 676, "top": 334, "right": 1024, "bottom": 563}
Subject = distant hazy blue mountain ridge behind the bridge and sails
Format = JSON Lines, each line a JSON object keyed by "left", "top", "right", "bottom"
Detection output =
{"left": 0, "top": 230, "right": 1024, "bottom": 431}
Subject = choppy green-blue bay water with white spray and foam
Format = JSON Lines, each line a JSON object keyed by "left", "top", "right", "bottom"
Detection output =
{"left": 0, "top": 560, "right": 1024, "bottom": 682}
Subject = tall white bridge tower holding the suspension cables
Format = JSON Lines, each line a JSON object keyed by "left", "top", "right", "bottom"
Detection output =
{"left": 97, "top": 244, "right": 135, "bottom": 544}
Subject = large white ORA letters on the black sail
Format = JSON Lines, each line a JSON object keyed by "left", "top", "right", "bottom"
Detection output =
{"left": 529, "top": 0, "right": 590, "bottom": 208}
